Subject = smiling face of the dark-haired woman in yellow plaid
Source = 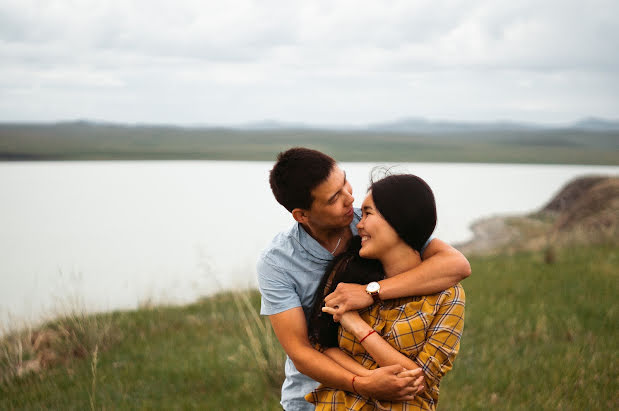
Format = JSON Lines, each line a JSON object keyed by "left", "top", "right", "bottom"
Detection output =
{"left": 357, "top": 192, "right": 402, "bottom": 260}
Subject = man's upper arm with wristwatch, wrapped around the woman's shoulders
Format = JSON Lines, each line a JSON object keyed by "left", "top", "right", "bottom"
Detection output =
{"left": 325, "top": 238, "right": 471, "bottom": 321}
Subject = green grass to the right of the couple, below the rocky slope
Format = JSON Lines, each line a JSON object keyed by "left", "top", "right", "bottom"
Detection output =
{"left": 440, "top": 245, "right": 619, "bottom": 410}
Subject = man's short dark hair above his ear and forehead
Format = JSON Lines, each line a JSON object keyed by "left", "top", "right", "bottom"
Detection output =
{"left": 269, "top": 147, "right": 335, "bottom": 212}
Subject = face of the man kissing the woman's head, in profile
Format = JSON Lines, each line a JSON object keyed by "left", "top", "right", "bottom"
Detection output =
{"left": 309, "top": 165, "right": 355, "bottom": 229}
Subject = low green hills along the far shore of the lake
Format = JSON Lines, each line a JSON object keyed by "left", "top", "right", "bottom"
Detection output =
{"left": 0, "top": 118, "right": 619, "bottom": 165}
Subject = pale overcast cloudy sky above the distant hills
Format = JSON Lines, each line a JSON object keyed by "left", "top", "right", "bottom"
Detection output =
{"left": 0, "top": 0, "right": 619, "bottom": 125}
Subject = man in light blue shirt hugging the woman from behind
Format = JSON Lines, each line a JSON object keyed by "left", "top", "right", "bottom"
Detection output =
{"left": 257, "top": 147, "right": 470, "bottom": 411}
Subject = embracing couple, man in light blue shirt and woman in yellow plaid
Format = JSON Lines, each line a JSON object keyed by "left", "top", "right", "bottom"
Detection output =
{"left": 257, "top": 148, "right": 470, "bottom": 411}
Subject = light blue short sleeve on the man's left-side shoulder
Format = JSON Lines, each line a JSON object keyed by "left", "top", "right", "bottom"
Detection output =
{"left": 256, "top": 256, "right": 301, "bottom": 315}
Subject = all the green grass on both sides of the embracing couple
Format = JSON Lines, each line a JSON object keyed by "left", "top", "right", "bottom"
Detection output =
{"left": 0, "top": 245, "right": 619, "bottom": 410}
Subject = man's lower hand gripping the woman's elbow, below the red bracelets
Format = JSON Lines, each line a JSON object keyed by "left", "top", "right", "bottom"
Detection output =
{"left": 355, "top": 365, "right": 423, "bottom": 401}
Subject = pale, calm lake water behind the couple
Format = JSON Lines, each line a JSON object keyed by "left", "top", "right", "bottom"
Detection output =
{"left": 0, "top": 161, "right": 619, "bottom": 327}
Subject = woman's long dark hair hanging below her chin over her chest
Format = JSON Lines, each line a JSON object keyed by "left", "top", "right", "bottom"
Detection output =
{"left": 308, "top": 236, "right": 385, "bottom": 348}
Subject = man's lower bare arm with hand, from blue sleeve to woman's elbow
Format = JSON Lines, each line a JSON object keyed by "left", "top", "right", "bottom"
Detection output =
{"left": 269, "top": 307, "right": 416, "bottom": 401}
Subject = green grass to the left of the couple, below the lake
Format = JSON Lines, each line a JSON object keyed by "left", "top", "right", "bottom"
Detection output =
{"left": 0, "top": 292, "right": 284, "bottom": 410}
